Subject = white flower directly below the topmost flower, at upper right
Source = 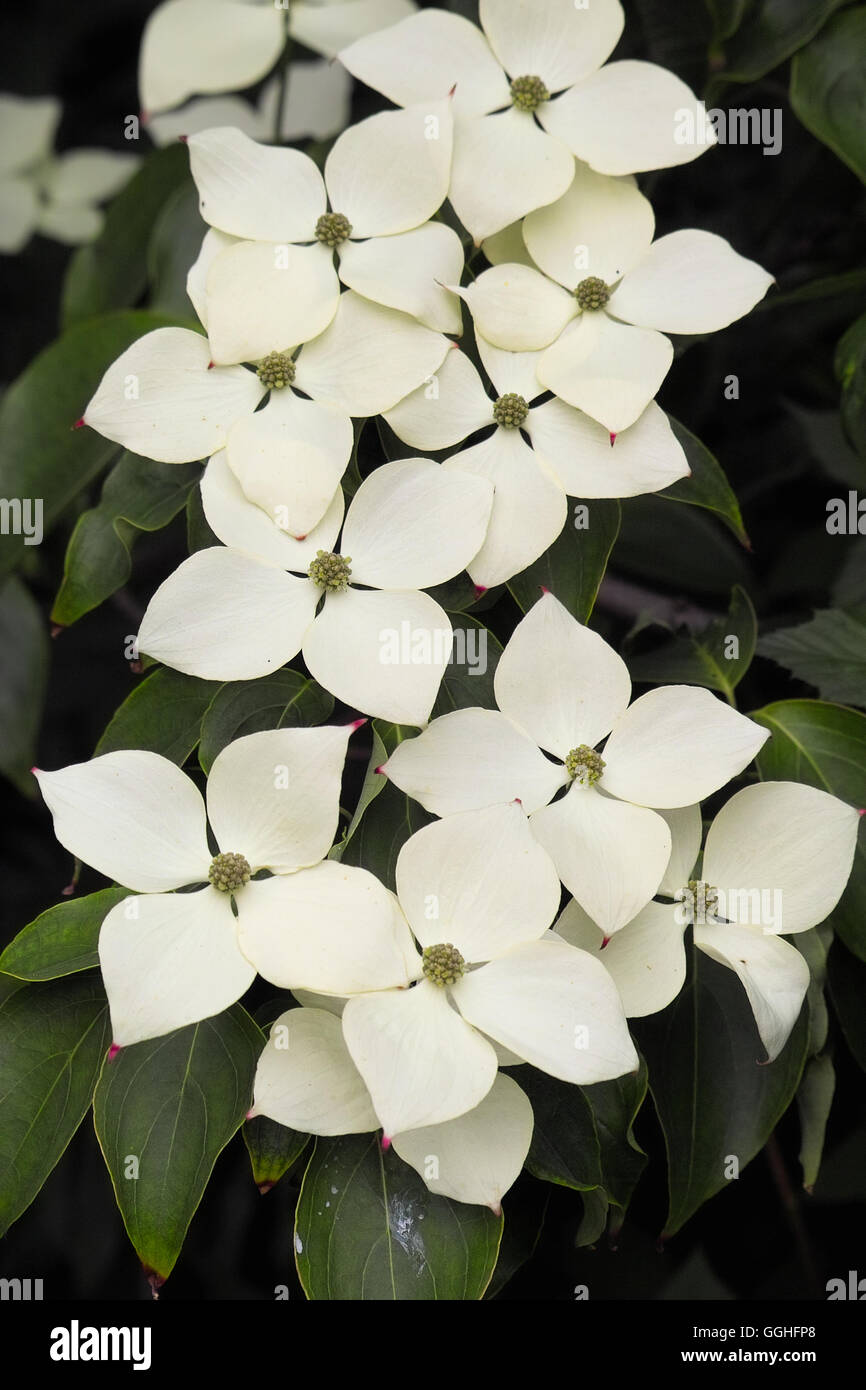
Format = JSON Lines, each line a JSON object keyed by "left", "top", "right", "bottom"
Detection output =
{"left": 457, "top": 164, "right": 773, "bottom": 434}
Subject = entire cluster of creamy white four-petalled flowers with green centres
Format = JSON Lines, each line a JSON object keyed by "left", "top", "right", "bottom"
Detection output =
{"left": 33, "top": 0, "right": 858, "bottom": 1208}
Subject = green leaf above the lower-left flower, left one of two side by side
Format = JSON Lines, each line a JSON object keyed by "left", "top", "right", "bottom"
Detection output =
{"left": 93, "top": 669, "right": 222, "bottom": 767}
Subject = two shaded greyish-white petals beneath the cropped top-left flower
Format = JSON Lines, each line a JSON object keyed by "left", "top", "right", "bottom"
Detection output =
{"left": 147, "top": 61, "right": 352, "bottom": 145}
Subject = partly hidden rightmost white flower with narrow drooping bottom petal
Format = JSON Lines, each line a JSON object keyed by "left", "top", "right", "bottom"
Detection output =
{"left": 556, "top": 783, "right": 859, "bottom": 1061}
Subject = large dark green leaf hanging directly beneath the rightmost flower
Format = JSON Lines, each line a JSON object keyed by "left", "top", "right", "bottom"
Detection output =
{"left": 632, "top": 951, "right": 809, "bottom": 1236}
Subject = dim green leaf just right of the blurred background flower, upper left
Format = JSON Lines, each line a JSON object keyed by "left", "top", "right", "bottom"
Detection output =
{"left": 63, "top": 143, "right": 195, "bottom": 328}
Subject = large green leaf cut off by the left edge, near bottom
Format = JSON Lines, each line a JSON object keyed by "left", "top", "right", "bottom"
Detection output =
{"left": 0, "top": 976, "right": 111, "bottom": 1236}
